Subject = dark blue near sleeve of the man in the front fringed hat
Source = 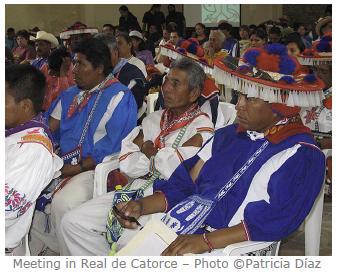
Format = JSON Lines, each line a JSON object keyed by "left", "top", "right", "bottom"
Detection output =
{"left": 244, "top": 145, "right": 325, "bottom": 241}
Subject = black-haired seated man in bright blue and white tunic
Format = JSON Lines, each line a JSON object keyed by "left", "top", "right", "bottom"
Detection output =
{"left": 32, "top": 38, "right": 137, "bottom": 252}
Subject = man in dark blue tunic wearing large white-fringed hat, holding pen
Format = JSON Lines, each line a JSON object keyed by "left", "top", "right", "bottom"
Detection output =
{"left": 111, "top": 44, "right": 325, "bottom": 255}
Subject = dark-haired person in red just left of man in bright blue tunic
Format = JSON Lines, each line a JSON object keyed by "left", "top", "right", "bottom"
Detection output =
{"left": 41, "top": 48, "right": 75, "bottom": 111}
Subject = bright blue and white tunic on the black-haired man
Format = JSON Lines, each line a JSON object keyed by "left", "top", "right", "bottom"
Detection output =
{"left": 49, "top": 78, "right": 137, "bottom": 164}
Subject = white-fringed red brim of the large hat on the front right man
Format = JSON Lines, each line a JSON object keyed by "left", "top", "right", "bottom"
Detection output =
{"left": 214, "top": 58, "right": 325, "bottom": 107}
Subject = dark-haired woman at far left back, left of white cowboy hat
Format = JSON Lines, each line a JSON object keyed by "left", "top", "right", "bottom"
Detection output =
{"left": 13, "top": 30, "right": 36, "bottom": 64}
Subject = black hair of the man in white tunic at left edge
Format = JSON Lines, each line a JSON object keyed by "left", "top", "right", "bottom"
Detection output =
{"left": 5, "top": 64, "right": 46, "bottom": 113}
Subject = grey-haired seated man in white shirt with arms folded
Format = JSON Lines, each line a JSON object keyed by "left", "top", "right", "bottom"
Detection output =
{"left": 60, "top": 58, "right": 213, "bottom": 255}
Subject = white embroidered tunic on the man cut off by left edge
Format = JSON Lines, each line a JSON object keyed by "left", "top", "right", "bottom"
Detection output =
{"left": 5, "top": 116, "right": 63, "bottom": 248}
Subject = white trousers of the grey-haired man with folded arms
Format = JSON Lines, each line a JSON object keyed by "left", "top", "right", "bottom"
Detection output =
{"left": 59, "top": 180, "right": 153, "bottom": 256}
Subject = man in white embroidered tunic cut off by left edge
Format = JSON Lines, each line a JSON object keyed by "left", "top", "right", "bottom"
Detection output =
{"left": 5, "top": 65, "right": 63, "bottom": 255}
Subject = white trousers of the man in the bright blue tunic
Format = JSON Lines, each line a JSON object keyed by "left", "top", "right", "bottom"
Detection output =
{"left": 30, "top": 170, "right": 94, "bottom": 255}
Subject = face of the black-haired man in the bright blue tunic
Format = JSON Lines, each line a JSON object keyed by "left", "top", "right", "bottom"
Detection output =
{"left": 73, "top": 53, "right": 103, "bottom": 90}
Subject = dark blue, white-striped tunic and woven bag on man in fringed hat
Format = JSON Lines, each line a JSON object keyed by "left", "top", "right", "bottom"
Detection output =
{"left": 154, "top": 125, "right": 325, "bottom": 241}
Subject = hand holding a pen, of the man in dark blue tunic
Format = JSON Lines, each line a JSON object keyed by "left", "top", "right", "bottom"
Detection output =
{"left": 114, "top": 200, "right": 143, "bottom": 229}
